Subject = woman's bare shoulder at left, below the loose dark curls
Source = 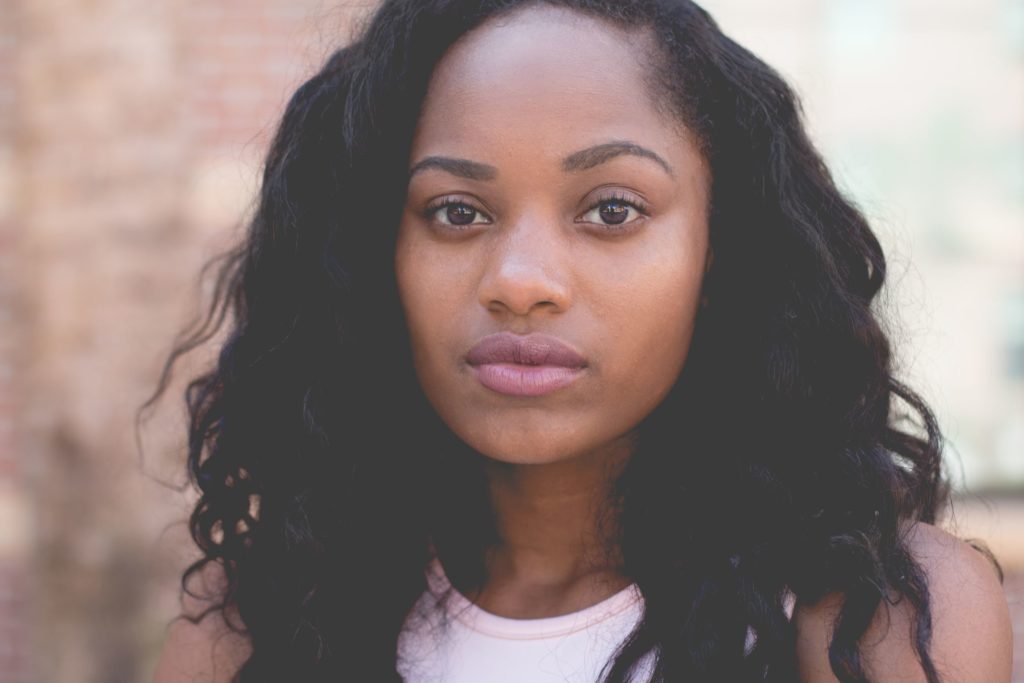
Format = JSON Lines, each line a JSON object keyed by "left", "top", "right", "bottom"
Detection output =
{"left": 154, "top": 562, "right": 250, "bottom": 683}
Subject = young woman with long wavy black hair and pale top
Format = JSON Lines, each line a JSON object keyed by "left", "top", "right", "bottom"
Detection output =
{"left": 148, "top": 0, "right": 1011, "bottom": 683}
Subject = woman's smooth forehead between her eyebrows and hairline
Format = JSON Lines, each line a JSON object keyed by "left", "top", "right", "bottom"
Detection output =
{"left": 412, "top": 5, "right": 682, "bottom": 166}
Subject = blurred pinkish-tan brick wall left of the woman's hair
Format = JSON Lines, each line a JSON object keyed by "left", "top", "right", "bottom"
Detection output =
{"left": 0, "top": 0, "right": 360, "bottom": 683}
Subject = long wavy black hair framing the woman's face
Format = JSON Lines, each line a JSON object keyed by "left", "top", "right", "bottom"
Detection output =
{"left": 147, "top": 0, "right": 966, "bottom": 683}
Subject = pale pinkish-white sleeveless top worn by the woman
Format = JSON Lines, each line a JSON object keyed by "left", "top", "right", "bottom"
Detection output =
{"left": 398, "top": 559, "right": 795, "bottom": 683}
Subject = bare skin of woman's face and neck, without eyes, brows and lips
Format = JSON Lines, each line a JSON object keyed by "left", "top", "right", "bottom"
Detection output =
{"left": 395, "top": 7, "right": 710, "bottom": 617}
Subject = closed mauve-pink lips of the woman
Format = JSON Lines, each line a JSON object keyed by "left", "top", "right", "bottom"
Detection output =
{"left": 466, "top": 332, "right": 587, "bottom": 396}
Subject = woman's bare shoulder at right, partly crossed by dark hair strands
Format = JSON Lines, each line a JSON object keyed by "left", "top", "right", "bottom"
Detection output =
{"left": 794, "top": 523, "right": 1013, "bottom": 683}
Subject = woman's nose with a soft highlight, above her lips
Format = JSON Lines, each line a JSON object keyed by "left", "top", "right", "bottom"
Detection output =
{"left": 479, "top": 217, "right": 570, "bottom": 315}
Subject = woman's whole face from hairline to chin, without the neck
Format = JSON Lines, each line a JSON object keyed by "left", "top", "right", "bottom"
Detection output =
{"left": 395, "top": 7, "right": 710, "bottom": 464}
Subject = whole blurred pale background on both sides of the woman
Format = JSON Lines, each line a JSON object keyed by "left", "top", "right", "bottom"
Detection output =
{"left": 0, "top": 0, "right": 1024, "bottom": 683}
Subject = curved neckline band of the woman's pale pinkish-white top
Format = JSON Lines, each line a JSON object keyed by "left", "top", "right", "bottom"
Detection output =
{"left": 427, "top": 557, "right": 643, "bottom": 640}
